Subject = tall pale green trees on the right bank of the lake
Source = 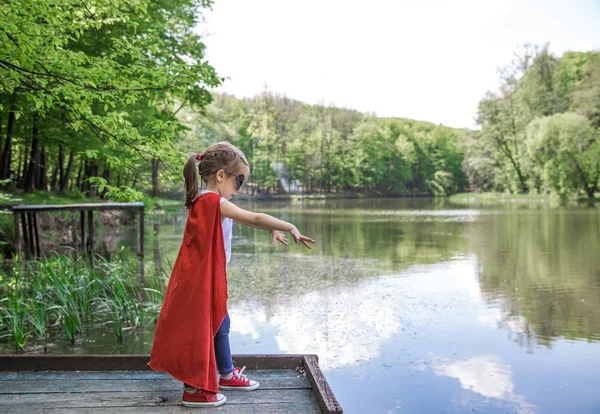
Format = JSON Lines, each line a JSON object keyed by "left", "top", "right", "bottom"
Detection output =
{"left": 464, "top": 45, "right": 600, "bottom": 198}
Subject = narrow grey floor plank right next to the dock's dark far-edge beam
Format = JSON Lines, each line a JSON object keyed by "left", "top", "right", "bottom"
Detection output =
{"left": 0, "top": 369, "right": 308, "bottom": 384}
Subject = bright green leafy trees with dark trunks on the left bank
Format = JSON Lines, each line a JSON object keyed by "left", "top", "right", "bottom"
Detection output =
{"left": 0, "top": 0, "right": 221, "bottom": 199}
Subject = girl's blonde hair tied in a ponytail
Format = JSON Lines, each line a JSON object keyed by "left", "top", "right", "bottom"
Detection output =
{"left": 183, "top": 141, "right": 248, "bottom": 209}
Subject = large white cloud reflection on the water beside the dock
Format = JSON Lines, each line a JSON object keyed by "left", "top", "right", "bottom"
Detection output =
{"left": 229, "top": 257, "right": 476, "bottom": 369}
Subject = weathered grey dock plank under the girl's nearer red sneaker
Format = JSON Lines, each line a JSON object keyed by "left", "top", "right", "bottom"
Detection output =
{"left": 0, "top": 389, "right": 319, "bottom": 412}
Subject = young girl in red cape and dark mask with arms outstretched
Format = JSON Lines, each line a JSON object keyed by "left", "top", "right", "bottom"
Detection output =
{"left": 148, "top": 142, "right": 315, "bottom": 407}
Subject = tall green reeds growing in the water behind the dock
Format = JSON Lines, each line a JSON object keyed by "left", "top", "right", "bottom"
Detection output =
{"left": 0, "top": 255, "right": 163, "bottom": 352}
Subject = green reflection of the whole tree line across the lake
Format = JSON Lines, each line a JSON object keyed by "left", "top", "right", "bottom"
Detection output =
{"left": 147, "top": 199, "right": 600, "bottom": 350}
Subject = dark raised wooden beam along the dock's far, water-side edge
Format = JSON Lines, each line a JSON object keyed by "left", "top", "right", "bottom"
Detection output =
{"left": 0, "top": 354, "right": 316, "bottom": 371}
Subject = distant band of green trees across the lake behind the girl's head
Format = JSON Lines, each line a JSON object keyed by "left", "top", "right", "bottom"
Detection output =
{"left": 184, "top": 92, "right": 466, "bottom": 195}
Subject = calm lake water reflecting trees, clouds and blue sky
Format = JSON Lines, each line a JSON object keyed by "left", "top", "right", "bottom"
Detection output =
{"left": 10, "top": 199, "right": 600, "bottom": 413}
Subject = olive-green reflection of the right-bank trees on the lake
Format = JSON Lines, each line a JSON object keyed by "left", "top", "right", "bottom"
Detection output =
{"left": 468, "top": 209, "right": 600, "bottom": 347}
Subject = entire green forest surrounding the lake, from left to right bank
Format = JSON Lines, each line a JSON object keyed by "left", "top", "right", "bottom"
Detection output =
{"left": 0, "top": 0, "right": 600, "bottom": 201}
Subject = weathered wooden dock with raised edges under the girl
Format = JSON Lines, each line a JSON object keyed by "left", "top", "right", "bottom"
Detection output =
{"left": 0, "top": 355, "right": 343, "bottom": 414}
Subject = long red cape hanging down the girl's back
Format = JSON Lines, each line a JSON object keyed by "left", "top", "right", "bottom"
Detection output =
{"left": 148, "top": 193, "right": 227, "bottom": 392}
